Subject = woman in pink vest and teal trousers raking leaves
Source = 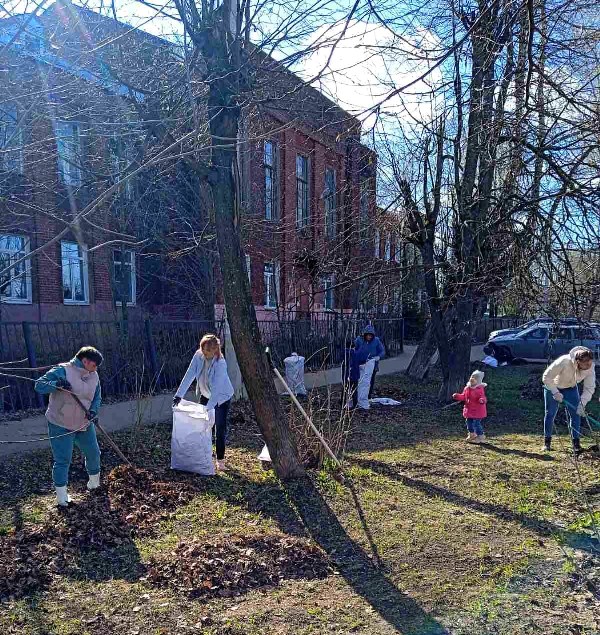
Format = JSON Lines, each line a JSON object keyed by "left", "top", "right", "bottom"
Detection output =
{"left": 35, "top": 346, "right": 104, "bottom": 507}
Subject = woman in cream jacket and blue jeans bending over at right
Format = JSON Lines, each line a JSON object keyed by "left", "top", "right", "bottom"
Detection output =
{"left": 542, "top": 346, "right": 596, "bottom": 452}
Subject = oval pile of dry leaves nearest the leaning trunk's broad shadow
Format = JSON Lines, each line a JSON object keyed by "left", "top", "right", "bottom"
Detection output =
{"left": 145, "top": 536, "right": 331, "bottom": 598}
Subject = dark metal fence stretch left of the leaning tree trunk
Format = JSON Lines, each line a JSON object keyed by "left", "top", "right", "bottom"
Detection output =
{"left": 0, "top": 320, "right": 222, "bottom": 412}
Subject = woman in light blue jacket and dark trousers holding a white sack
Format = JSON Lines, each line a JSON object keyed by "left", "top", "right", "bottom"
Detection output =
{"left": 173, "top": 335, "right": 234, "bottom": 471}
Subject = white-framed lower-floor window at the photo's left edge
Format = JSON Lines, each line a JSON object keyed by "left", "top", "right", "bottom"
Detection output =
{"left": 0, "top": 235, "right": 31, "bottom": 304}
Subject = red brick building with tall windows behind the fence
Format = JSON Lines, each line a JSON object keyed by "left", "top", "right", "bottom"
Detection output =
{"left": 0, "top": 1, "right": 380, "bottom": 321}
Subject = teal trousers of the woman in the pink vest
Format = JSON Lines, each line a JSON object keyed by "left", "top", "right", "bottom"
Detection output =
{"left": 48, "top": 421, "right": 100, "bottom": 487}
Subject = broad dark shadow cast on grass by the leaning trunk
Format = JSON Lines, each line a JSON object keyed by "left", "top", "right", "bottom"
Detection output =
{"left": 218, "top": 470, "right": 449, "bottom": 635}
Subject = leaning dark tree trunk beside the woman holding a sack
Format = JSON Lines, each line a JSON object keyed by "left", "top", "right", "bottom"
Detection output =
{"left": 204, "top": 28, "right": 304, "bottom": 479}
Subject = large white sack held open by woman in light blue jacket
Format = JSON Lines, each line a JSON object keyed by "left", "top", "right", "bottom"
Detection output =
{"left": 171, "top": 399, "right": 215, "bottom": 476}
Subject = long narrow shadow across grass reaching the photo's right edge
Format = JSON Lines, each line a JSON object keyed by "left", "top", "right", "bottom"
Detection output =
{"left": 352, "top": 458, "right": 600, "bottom": 554}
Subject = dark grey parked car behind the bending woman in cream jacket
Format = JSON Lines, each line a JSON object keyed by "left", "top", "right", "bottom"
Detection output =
{"left": 483, "top": 323, "right": 600, "bottom": 361}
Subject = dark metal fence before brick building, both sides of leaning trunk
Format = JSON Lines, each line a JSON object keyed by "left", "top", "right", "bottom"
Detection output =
{"left": 0, "top": 314, "right": 403, "bottom": 412}
